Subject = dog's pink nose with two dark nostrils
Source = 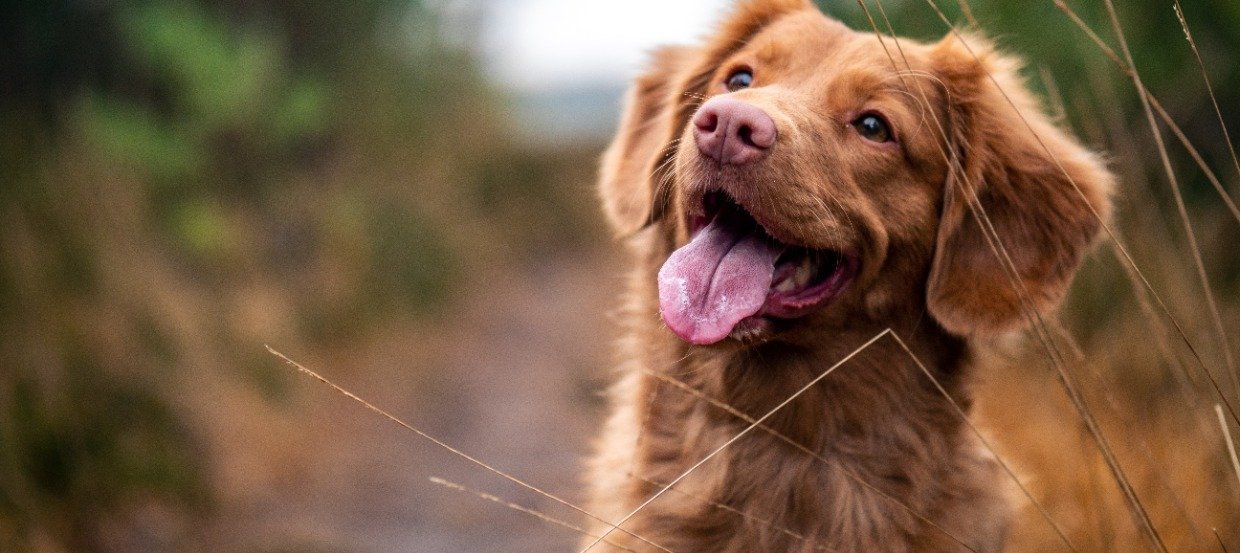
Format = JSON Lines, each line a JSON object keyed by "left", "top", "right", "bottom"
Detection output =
{"left": 693, "top": 97, "right": 776, "bottom": 165}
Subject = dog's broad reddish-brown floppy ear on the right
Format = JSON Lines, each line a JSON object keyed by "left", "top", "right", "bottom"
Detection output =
{"left": 926, "top": 35, "right": 1114, "bottom": 336}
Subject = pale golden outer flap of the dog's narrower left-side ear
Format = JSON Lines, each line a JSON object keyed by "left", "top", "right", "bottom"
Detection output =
{"left": 599, "top": 47, "right": 693, "bottom": 234}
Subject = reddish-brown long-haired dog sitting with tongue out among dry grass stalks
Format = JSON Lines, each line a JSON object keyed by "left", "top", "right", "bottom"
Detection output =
{"left": 580, "top": 0, "right": 1112, "bottom": 553}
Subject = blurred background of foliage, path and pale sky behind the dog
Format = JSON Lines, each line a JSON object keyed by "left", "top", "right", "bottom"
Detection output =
{"left": 0, "top": 0, "right": 1240, "bottom": 553}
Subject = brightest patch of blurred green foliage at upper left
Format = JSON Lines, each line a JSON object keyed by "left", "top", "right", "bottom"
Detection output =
{"left": 82, "top": 2, "right": 330, "bottom": 188}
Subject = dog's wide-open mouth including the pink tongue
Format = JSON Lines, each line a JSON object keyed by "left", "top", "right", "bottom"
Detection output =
{"left": 658, "top": 192, "right": 861, "bottom": 345}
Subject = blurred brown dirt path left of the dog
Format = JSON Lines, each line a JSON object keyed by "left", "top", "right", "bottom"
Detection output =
{"left": 211, "top": 258, "right": 620, "bottom": 552}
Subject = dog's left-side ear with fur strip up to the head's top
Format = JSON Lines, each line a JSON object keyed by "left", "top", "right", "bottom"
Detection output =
{"left": 599, "top": 0, "right": 813, "bottom": 236}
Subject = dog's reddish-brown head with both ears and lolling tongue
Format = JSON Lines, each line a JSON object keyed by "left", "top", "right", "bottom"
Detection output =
{"left": 600, "top": 0, "right": 1112, "bottom": 343}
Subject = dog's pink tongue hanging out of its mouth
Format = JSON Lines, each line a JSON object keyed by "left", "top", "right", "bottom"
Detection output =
{"left": 658, "top": 211, "right": 784, "bottom": 345}
